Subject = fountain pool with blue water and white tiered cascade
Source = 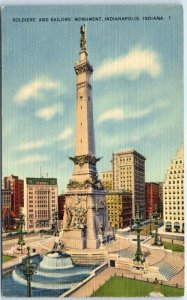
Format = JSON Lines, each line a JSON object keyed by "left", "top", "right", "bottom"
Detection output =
{"left": 2, "top": 252, "right": 97, "bottom": 297}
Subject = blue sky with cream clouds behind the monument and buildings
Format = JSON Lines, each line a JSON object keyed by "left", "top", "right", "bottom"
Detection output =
{"left": 2, "top": 6, "right": 183, "bottom": 193}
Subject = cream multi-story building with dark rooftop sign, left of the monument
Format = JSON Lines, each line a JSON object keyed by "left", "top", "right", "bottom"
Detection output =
{"left": 25, "top": 178, "right": 58, "bottom": 231}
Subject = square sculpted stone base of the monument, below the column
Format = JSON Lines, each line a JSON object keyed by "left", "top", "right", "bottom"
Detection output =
{"left": 62, "top": 190, "right": 108, "bottom": 249}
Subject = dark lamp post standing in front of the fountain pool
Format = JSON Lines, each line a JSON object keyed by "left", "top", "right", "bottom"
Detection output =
{"left": 22, "top": 247, "right": 36, "bottom": 297}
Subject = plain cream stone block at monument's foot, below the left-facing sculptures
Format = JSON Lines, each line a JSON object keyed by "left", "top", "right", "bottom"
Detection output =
{"left": 63, "top": 229, "right": 86, "bottom": 250}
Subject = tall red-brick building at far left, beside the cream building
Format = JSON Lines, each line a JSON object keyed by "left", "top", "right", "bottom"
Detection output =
{"left": 4, "top": 175, "right": 24, "bottom": 216}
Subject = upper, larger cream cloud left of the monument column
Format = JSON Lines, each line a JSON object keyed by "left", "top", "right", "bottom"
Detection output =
{"left": 15, "top": 79, "right": 59, "bottom": 103}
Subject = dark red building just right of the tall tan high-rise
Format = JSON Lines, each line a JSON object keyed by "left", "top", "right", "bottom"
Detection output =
{"left": 145, "top": 182, "right": 160, "bottom": 219}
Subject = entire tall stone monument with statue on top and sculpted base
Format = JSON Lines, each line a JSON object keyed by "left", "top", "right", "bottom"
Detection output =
{"left": 62, "top": 25, "right": 108, "bottom": 249}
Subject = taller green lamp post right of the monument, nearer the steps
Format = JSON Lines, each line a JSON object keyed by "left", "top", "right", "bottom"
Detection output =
{"left": 133, "top": 205, "right": 145, "bottom": 263}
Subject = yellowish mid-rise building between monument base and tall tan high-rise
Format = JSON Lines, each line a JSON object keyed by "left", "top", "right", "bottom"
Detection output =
{"left": 105, "top": 190, "right": 132, "bottom": 229}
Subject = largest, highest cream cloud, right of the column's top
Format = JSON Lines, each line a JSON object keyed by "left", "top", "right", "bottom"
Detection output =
{"left": 94, "top": 46, "right": 161, "bottom": 80}
